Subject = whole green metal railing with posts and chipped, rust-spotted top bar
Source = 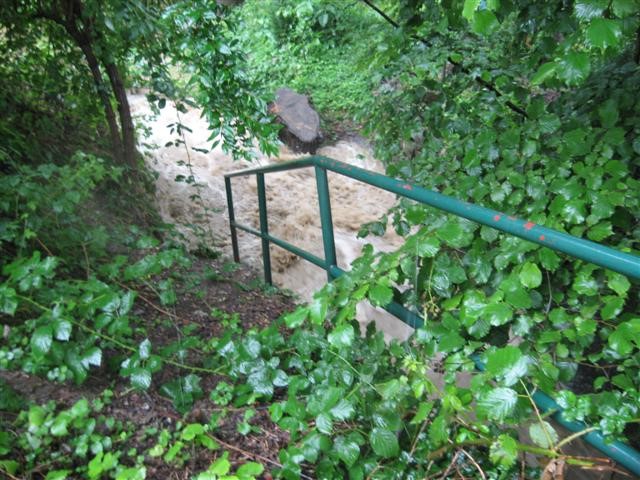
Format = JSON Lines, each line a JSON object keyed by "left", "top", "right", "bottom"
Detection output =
{"left": 224, "top": 156, "right": 640, "bottom": 476}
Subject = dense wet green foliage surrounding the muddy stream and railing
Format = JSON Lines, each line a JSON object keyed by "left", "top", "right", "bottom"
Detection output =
{"left": 0, "top": 0, "right": 640, "bottom": 480}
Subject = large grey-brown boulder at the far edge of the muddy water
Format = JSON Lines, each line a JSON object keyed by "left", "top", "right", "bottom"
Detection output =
{"left": 271, "top": 88, "right": 322, "bottom": 153}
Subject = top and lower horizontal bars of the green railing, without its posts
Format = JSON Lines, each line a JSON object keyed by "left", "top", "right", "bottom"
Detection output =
{"left": 225, "top": 156, "right": 640, "bottom": 475}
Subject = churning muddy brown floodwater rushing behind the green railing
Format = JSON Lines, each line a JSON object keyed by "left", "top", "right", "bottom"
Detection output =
{"left": 129, "top": 94, "right": 412, "bottom": 339}
